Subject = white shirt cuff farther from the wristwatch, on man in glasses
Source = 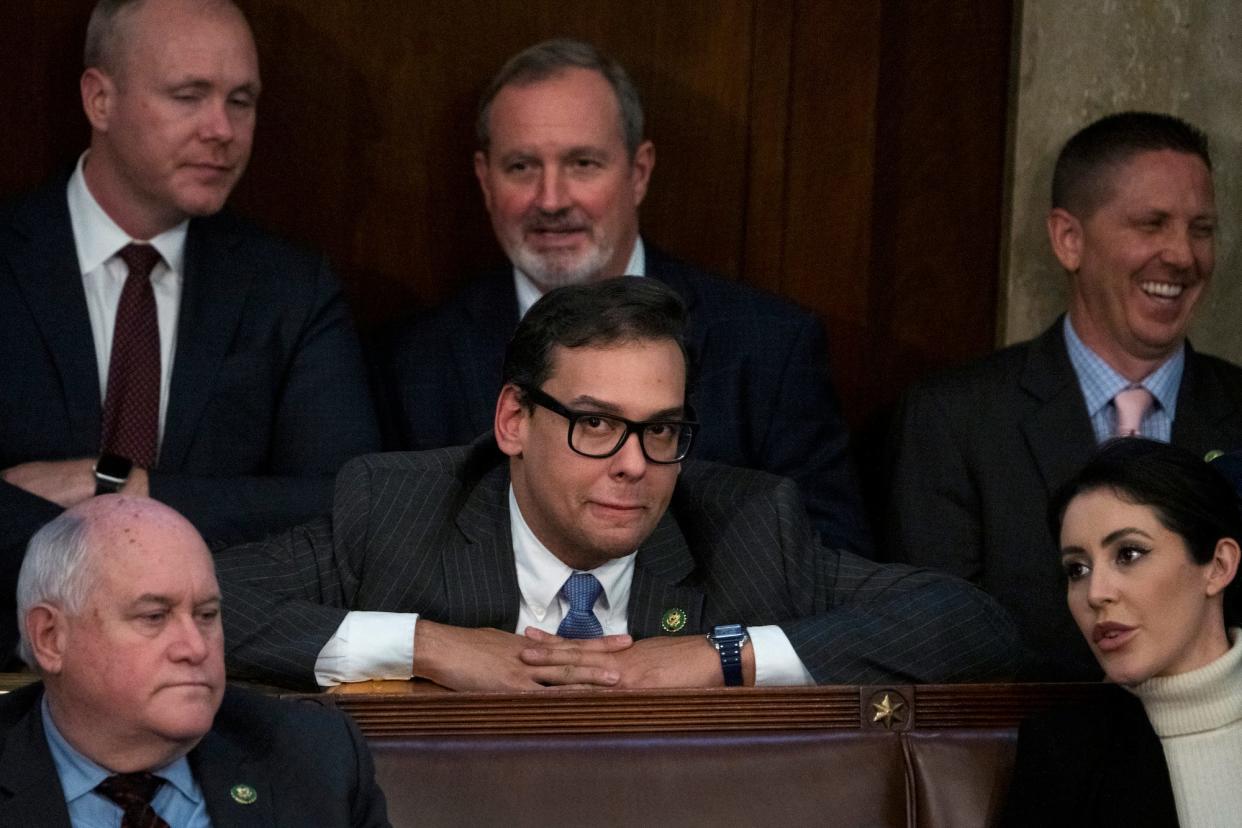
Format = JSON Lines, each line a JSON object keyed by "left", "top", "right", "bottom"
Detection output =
{"left": 314, "top": 612, "right": 419, "bottom": 686}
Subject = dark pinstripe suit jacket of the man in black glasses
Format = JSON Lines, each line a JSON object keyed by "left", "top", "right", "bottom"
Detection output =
{"left": 216, "top": 439, "right": 1017, "bottom": 686}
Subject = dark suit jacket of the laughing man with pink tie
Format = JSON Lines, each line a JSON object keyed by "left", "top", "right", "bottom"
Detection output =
{"left": 887, "top": 320, "right": 1242, "bottom": 679}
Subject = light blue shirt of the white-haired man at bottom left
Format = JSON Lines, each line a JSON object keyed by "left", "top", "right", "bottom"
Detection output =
{"left": 41, "top": 696, "right": 211, "bottom": 828}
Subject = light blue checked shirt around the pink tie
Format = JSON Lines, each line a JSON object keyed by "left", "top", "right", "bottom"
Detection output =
{"left": 1063, "top": 315, "right": 1186, "bottom": 443}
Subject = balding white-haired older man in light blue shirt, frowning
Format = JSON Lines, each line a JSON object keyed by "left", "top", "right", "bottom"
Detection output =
{"left": 0, "top": 495, "right": 388, "bottom": 828}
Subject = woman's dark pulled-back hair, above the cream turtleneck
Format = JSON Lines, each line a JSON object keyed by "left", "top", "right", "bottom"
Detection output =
{"left": 1048, "top": 437, "right": 1242, "bottom": 622}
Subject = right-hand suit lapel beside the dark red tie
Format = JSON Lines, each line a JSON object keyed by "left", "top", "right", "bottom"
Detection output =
{"left": 159, "top": 216, "right": 253, "bottom": 470}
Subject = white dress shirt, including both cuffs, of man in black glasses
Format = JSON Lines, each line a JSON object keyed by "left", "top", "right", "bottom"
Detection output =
{"left": 314, "top": 485, "right": 815, "bottom": 686}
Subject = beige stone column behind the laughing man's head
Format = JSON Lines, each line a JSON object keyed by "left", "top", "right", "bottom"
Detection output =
{"left": 999, "top": 0, "right": 1242, "bottom": 362}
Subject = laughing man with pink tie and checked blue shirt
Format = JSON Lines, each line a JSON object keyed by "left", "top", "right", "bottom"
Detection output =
{"left": 888, "top": 112, "right": 1242, "bottom": 679}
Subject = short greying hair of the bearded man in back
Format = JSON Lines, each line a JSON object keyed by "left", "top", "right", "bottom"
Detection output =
{"left": 474, "top": 37, "right": 642, "bottom": 156}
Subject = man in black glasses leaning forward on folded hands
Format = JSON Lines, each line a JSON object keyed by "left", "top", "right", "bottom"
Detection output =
{"left": 217, "top": 278, "right": 1017, "bottom": 690}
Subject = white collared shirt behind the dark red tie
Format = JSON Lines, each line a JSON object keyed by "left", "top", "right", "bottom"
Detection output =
{"left": 67, "top": 150, "right": 189, "bottom": 442}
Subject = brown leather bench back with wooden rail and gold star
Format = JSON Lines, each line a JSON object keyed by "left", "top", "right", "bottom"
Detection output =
{"left": 335, "top": 685, "right": 1099, "bottom": 828}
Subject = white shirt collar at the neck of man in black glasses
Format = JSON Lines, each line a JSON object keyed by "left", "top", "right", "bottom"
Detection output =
{"left": 509, "top": 483, "right": 637, "bottom": 613}
